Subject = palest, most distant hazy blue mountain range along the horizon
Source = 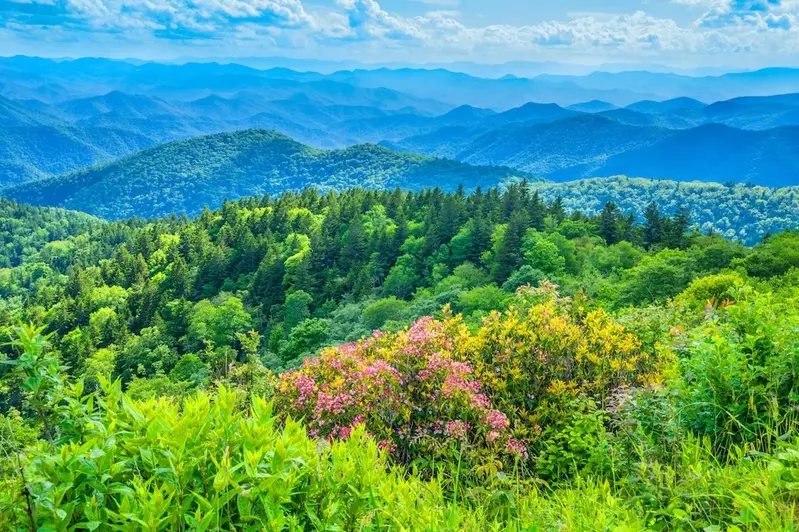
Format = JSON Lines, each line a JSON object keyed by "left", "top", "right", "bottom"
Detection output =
{"left": 0, "top": 56, "right": 799, "bottom": 111}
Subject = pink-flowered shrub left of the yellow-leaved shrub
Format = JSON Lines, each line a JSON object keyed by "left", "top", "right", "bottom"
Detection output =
{"left": 276, "top": 318, "right": 512, "bottom": 470}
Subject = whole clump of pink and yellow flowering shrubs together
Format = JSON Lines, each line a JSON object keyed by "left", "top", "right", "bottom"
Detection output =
{"left": 276, "top": 287, "right": 658, "bottom": 472}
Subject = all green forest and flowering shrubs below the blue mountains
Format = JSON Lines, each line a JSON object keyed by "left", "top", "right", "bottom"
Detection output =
{"left": 0, "top": 180, "right": 799, "bottom": 531}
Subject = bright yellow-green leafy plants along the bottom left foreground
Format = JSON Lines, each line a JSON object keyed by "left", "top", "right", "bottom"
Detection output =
{"left": 0, "top": 381, "right": 643, "bottom": 531}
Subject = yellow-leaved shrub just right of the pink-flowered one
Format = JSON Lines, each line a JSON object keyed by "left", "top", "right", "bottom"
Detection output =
{"left": 455, "top": 286, "right": 665, "bottom": 442}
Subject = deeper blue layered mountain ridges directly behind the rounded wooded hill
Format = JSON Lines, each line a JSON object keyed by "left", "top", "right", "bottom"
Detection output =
{"left": 0, "top": 85, "right": 799, "bottom": 185}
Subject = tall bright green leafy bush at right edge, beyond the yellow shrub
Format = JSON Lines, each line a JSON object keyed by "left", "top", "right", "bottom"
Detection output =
{"left": 680, "top": 288, "right": 799, "bottom": 453}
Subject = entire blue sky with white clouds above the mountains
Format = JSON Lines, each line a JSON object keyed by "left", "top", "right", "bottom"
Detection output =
{"left": 0, "top": 0, "right": 799, "bottom": 68}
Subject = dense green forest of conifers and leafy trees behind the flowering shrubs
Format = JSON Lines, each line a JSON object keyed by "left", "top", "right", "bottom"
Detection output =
{"left": 0, "top": 182, "right": 794, "bottom": 382}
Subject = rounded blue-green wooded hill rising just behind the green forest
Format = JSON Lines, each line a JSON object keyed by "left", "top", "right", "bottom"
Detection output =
{"left": 4, "top": 130, "right": 532, "bottom": 219}
